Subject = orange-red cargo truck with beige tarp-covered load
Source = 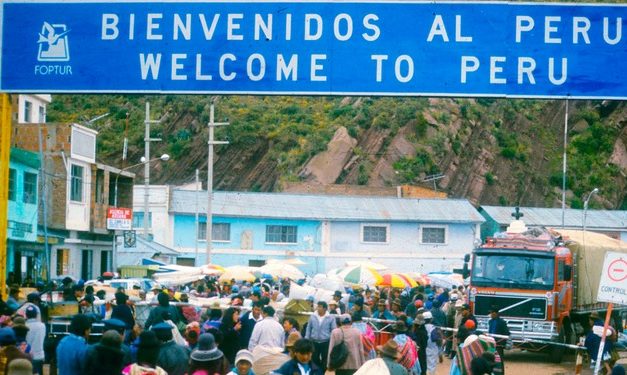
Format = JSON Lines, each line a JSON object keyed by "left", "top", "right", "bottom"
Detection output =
{"left": 469, "top": 220, "right": 627, "bottom": 362}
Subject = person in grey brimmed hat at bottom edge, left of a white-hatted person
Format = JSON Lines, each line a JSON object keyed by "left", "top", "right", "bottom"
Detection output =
{"left": 189, "top": 333, "right": 229, "bottom": 375}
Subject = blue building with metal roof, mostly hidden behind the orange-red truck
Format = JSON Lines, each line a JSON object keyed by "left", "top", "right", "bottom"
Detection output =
{"left": 479, "top": 206, "right": 627, "bottom": 241}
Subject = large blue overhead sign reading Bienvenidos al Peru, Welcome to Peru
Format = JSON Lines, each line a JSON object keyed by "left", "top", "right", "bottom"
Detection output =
{"left": 0, "top": 0, "right": 627, "bottom": 99}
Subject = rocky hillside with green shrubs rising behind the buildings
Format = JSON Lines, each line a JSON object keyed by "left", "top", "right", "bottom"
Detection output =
{"left": 48, "top": 95, "right": 627, "bottom": 209}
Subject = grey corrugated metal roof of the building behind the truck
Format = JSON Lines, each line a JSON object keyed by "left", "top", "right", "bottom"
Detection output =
{"left": 480, "top": 206, "right": 627, "bottom": 230}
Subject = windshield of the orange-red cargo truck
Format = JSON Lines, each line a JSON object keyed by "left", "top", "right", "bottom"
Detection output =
{"left": 471, "top": 254, "right": 554, "bottom": 290}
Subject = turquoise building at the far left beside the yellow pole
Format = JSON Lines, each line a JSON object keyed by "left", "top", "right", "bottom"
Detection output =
{"left": 7, "top": 148, "right": 45, "bottom": 280}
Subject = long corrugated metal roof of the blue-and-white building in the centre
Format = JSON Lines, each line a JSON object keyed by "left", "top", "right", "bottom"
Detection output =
{"left": 170, "top": 189, "right": 485, "bottom": 223}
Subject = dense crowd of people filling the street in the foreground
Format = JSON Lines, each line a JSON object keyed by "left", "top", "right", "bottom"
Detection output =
{"left": 0, "top": 278, "right": 624, "bottom": 375}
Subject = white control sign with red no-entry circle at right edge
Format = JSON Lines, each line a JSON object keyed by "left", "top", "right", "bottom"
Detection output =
{"left": 597, "top": 252, "right": 627, "bottom": 305}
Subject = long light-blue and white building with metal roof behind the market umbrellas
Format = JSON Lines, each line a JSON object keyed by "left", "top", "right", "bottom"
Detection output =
{"left": 168, "top": 189, "right": 484, "bottom": 274}
